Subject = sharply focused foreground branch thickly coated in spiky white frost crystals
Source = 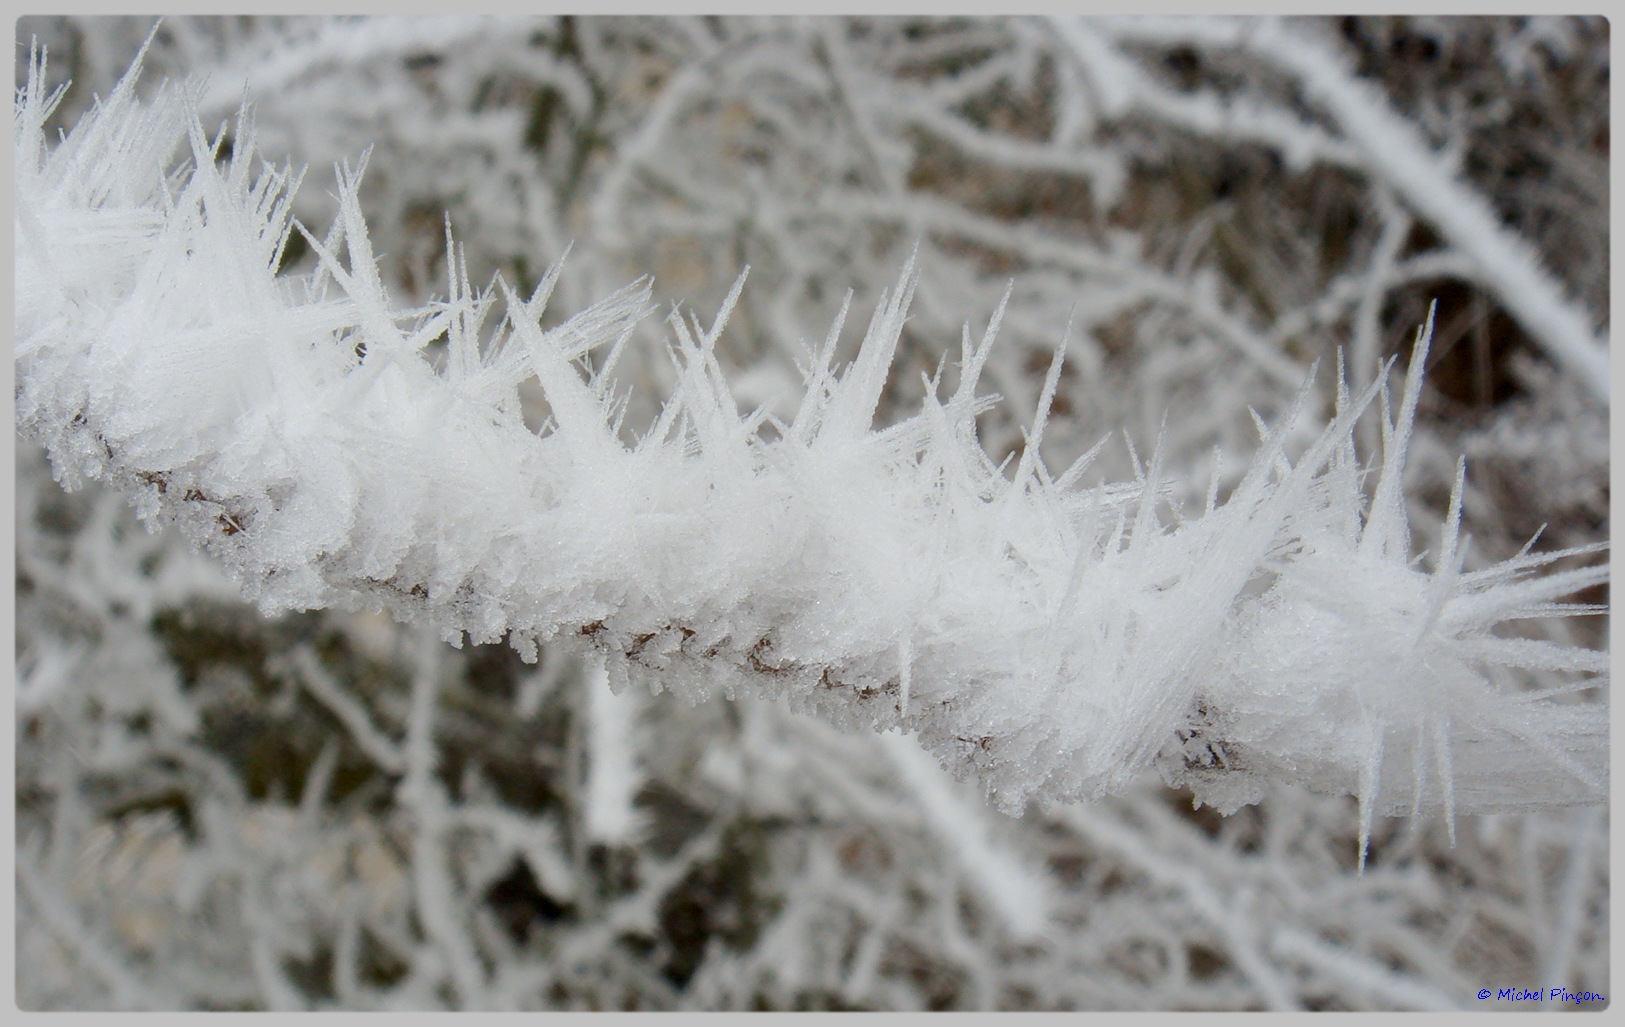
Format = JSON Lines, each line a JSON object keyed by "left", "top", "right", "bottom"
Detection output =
{"left": 16, "top": 40, "right": 1607, "bottom": 845}
